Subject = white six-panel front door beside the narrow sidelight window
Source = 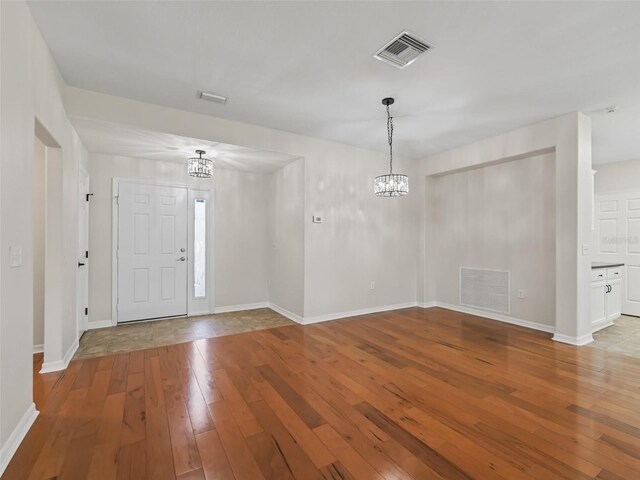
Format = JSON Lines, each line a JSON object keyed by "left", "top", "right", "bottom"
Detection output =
{"left": 117, "top": 182, "right": 188, "bottom": 323}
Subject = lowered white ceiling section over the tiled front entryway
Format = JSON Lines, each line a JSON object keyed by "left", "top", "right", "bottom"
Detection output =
{"left": 71, "top": 118, "right": 298, "bottom": 173}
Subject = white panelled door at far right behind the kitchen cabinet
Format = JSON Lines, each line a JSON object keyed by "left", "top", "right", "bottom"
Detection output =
{"left": 594, "top": 192, "right": 640, "bottom": 316}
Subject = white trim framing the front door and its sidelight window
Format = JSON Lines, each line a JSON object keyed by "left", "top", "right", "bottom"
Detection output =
{"left": 111, "top": 177, "right": 215, "bottom": 327}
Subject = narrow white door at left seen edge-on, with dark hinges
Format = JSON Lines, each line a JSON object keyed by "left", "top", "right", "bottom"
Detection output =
{"left": 76, "top": 170, "right": 90, "bottom": 337}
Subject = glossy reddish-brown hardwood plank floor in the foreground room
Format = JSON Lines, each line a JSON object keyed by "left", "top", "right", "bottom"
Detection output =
{"left": 2, "top": 308, "right": 640, "bottom": 480}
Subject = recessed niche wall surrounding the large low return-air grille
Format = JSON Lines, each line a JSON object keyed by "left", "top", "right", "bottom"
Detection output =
{"left": 432, "top": 154, "right": 556, "bottom": 327}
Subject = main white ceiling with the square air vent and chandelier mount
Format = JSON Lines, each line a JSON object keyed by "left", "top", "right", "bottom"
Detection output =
{"left": 30, "top": 1, "right": 640, "bottom": 163}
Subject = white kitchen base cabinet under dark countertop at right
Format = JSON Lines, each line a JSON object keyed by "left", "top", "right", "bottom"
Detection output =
{"left": 591, "top": 268, "right": 622, "bottom": 332}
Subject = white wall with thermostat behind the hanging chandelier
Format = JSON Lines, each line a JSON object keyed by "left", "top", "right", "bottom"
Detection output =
{"left": 304, "top": 147, "right": 421, "bottom": 321}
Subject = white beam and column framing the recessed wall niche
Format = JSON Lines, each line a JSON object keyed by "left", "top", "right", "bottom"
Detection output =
{"left": 419, "top": 112, "right": 592, "bottom": 345}
